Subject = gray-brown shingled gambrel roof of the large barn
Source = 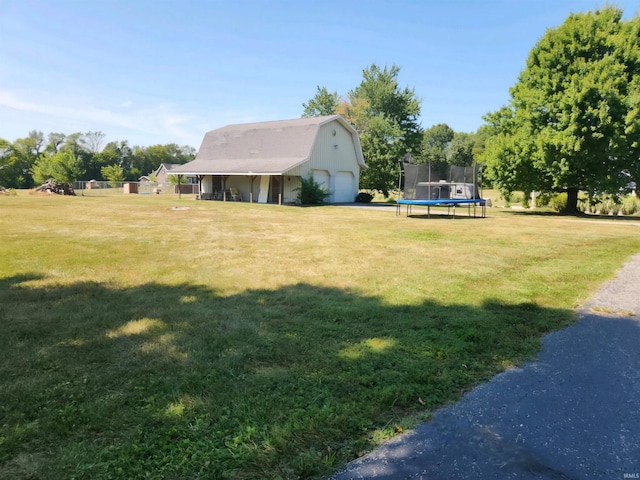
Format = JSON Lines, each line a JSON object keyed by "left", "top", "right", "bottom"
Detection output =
{"left": 171, "top": 115, "right": 364, "bottom": 175}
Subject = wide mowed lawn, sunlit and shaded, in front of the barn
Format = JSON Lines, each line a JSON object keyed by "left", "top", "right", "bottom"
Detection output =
{"left": 0, "top": 192, "right": 640, "bottom": 480}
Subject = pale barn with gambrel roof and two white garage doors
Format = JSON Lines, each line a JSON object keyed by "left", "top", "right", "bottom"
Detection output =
{"left": 171, "top": 115, "right": 367, "bottom": 204}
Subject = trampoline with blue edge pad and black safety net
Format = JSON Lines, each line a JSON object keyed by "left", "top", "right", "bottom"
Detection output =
{"left": 396, "top": 154, "right": 487, "bottom": 218}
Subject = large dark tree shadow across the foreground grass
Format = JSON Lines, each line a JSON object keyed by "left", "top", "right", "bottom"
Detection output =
{"left": 0, "top": 275, "right": 574, "bottom": 479}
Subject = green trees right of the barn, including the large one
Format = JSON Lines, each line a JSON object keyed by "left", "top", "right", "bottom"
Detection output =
{"left": 302, "top": 6, "right": 640, "bottom": 213}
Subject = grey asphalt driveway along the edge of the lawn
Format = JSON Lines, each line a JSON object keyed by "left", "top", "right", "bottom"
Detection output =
{"left": 331, "top": 255, "right": 640, "bottom": 480}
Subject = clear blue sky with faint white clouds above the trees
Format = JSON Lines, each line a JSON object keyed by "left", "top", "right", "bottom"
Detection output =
{"left": 0, "top": 0, "right": 640, "bottom": 148}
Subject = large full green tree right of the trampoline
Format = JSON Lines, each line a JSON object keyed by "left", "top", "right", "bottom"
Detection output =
{"left": 483, "top": 7, "right": 640, "bottom": 212}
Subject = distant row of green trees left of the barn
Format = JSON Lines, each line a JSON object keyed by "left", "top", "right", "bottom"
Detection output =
{"left": 0, "top": 130, "right": 196, "bottom": 188}
